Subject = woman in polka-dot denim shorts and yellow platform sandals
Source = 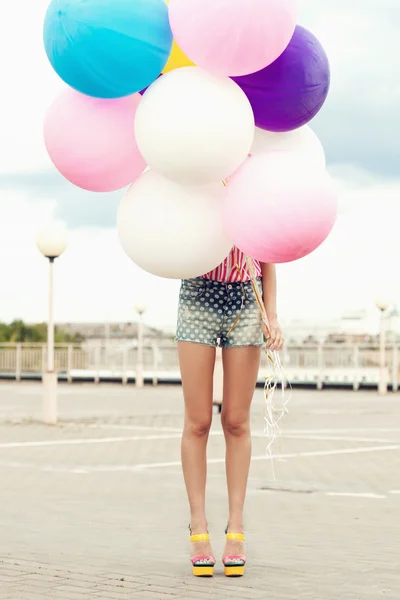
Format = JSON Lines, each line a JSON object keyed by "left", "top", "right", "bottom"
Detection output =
{"left": 176, "top": 248, "right": 283, "bottom": 576}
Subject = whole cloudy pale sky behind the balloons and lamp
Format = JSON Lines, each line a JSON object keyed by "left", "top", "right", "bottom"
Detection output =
{"left": 0, "top": 0, "right": 400, "bottom": 326}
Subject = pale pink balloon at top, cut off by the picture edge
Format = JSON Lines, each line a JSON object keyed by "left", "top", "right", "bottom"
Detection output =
{"left": 169, "top": 0, "right": 296, "bottom": 76}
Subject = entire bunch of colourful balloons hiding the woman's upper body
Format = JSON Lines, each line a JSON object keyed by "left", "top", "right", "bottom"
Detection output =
{"left": 45, "top": 0, "right": 336, "bottom": 278}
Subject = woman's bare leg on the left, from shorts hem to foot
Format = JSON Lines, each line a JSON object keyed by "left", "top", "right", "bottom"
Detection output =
{"left": 178, "top": 342, "right": 215, "bottom": 556}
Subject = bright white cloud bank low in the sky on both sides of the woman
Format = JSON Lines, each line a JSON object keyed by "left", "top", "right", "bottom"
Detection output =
{"left": 0, "top": 172, "right": 400, "bottom": 328}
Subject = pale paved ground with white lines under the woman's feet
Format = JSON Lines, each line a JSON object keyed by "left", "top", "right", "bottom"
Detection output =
{"left": 0, "top": 384, "right": 400, "bottom": 600}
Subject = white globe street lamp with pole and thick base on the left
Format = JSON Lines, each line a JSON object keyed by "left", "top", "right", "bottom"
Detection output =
{"left": 36, "top": 224, "right": 67, "bottom": 425}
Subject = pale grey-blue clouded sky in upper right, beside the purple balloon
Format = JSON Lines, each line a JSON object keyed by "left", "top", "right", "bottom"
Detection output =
{"left": 300, "top": 0, "right": 400, "bottom": 176}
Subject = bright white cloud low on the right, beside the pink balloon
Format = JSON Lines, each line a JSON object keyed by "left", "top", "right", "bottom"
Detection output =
{"left": 279, "top": 170, "right": 400, "bottom": 319}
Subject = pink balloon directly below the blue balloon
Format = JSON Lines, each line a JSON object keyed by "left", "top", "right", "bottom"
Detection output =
{"left": 44, "top": 88, "right": 146, "bottom": 192}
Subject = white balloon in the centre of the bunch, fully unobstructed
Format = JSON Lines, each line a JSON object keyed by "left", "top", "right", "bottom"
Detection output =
{"left": 135, "top": 67, "right": 255, "bottom": 185}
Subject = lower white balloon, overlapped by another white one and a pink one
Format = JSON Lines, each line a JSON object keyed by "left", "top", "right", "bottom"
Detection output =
{"left": 117, "top": 171, "right": 232, "bottom": 279}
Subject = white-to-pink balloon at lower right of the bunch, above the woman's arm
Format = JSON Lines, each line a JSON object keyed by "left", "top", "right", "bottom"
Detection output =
{"left": 224, "top": 151, "right": 337, "bottom": 263}
